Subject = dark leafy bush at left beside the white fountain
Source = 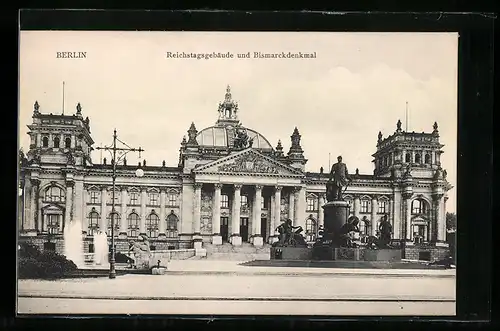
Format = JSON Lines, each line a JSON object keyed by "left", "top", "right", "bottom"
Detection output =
{"left": 18, "top": 244, "right": 78, "bottom": 279}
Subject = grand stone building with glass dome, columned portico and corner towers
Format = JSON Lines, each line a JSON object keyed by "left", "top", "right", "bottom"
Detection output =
{"left": 19, "top": 87, "right": 451, "bottom": 260}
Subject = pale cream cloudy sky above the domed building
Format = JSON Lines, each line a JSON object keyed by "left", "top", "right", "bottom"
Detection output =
{"left": 19, "top": 31, "right": 458, "bottom": 212}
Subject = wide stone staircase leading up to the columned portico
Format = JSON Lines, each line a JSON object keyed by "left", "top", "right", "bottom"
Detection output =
{"left": 198, "top": 243, "right": 271, "bottom": 261}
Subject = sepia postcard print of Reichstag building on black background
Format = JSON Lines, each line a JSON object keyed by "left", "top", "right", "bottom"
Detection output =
{"left": 16, "top": 30, "right": 460, "bottom": 317}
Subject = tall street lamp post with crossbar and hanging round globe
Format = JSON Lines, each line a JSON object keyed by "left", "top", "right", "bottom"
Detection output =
{"left": 96, "top": 129, "right": 144, "bottom": 279}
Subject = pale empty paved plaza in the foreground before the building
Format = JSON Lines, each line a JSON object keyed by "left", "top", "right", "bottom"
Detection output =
{"left": 18, "top": 261, "right": 455, "bottom": 315}
